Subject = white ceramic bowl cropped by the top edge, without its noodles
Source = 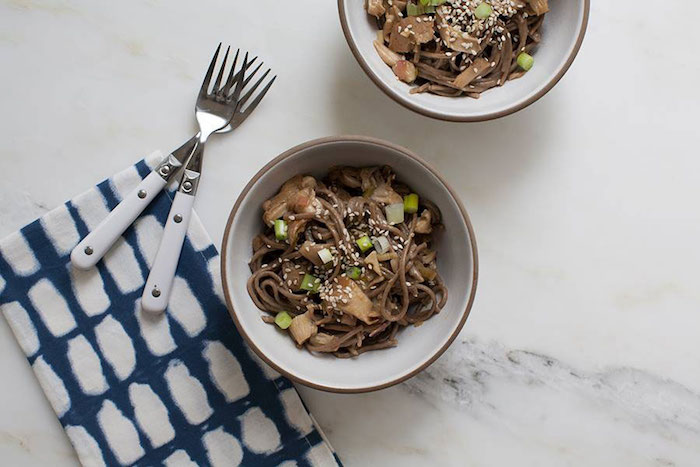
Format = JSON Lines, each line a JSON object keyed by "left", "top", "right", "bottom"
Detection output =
{"left": 338, "top": 0, "right": 590, "bottom": 122}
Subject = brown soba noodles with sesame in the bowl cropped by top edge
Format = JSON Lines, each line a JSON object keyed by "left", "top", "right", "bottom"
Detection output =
{"left": 366, "top": 0, "right": 549, "bottom": 98}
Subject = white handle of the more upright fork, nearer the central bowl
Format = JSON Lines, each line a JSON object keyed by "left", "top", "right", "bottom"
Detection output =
{"left": 141, "top": 191, "right": 194, "bottom": 313}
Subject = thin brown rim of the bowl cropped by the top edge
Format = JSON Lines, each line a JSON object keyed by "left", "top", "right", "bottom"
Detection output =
{"left": 338, "top": 0, "right": 591, "bottom": 122}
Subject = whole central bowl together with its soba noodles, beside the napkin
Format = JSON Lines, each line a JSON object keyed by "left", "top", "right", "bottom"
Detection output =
{"left": 221, "top": 136, "right": 478, "bottom": 392}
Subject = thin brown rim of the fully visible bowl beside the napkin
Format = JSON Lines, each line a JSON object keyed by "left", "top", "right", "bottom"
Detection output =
{"left": 221, "top": 135, "right": 479, "bottom": 394}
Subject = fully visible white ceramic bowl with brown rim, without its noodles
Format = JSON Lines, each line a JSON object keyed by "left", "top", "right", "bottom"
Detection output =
{"left": 221, "top": 136, "right": 478, "bottom": 392}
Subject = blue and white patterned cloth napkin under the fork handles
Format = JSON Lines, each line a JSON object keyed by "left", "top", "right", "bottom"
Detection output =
{"left": 0, "top": 153, "right": 339, "bottom": 466}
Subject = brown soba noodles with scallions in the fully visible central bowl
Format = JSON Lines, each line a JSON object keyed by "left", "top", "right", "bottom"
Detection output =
{"left": 247, "top": 167, "right": 447, "bottom": 357}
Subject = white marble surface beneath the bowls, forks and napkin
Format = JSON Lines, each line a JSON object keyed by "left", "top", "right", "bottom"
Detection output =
{"left": 0, "top": 0, "right": 700, "bottom": 466}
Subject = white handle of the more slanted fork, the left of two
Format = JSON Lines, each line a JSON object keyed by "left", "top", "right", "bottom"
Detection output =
{"left": 70, "top": 171, "right": 167, "bottom": 269}
